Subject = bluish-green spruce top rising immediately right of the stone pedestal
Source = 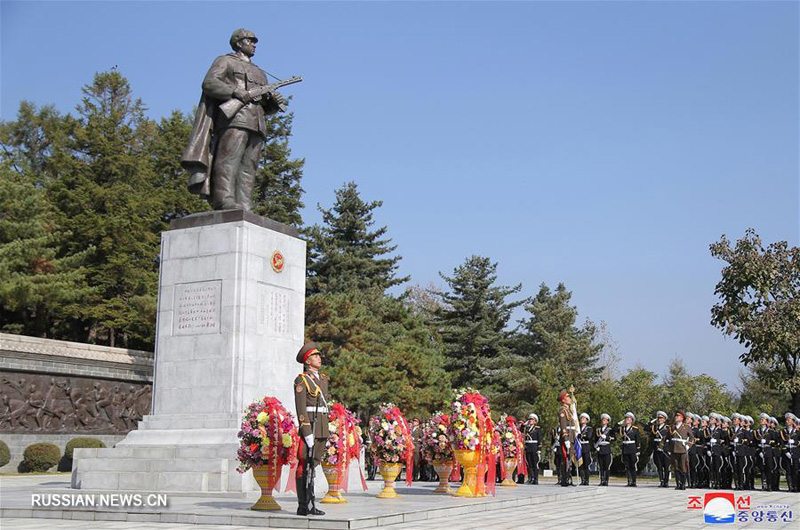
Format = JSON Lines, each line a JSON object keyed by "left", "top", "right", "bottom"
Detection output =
{"left": 307, "top": 182, "right": 408, "bottom": 294}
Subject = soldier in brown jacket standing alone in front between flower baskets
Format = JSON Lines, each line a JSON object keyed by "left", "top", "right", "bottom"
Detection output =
{"left": 294, "top": 342, "right": 328, "bottom": 515}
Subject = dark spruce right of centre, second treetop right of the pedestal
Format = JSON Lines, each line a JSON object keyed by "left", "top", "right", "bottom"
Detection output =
{"left": 433, "top": 256, "right": 525, "bottom": 397}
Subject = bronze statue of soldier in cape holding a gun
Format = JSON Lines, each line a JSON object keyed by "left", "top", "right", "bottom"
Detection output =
{"left": 181, "top": 29, "right": 286, "bottom": 211}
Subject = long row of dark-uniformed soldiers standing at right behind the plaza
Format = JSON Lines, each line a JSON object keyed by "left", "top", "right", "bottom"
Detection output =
{"left": 523, "top": 406, "right": 800, "bottom": 492}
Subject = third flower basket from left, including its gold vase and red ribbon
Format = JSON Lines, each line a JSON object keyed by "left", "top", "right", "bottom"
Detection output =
{"left": 369, "top": 403, "right": 414, "bottom": 499}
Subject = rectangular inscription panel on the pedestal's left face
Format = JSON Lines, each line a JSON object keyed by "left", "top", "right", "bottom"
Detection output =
{"left": 172, "top": 280, "right": 222, "bottom": 335}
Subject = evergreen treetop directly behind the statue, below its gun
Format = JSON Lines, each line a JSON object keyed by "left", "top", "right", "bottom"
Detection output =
{"left": 253, "top": 109, "right": 305, "bottom": 228}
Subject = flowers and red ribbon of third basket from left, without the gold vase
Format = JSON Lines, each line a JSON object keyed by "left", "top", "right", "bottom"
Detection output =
{"left": 369, "top": 403, "right": 414, "bottom": 484}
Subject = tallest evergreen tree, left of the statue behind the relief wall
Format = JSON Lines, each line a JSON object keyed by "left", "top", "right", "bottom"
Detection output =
{"left": 51, "top": 72, "right": 163, "bottom": 348}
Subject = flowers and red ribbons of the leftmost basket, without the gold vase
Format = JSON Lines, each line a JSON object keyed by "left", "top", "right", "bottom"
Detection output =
{"left": 237, "top": 396, "right": 300, "bottom": 473}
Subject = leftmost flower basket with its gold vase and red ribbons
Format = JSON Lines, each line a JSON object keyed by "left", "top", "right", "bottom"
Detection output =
{"left": 237, "top": 396, "right": 300, "bottom": 510}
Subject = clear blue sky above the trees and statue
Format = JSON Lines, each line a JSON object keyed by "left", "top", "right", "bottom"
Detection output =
{"left": 0, "top": 0, "right": 800, "bottom": 392}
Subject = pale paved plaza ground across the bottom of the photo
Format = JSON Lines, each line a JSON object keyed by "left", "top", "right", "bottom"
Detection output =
{"left": 0, "top": 476, "right": 800, "bottom": 530}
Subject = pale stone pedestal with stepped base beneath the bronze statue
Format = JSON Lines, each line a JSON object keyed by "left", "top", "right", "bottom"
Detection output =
{"left": 72, "top": 210, "right": 306, "bottom": 492}
